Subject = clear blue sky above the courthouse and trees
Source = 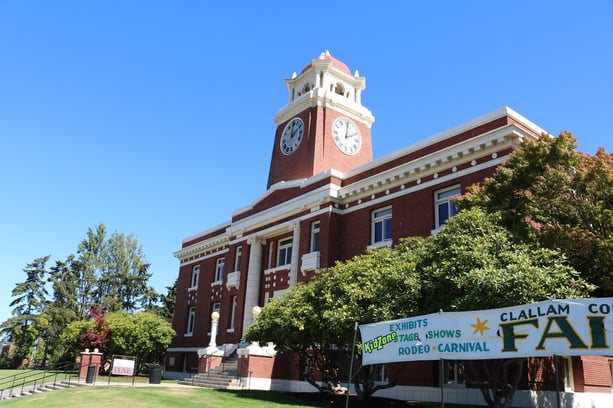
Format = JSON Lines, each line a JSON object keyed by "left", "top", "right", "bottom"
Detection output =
{"left": 0, "top": 0, "right": 613, "bottom": 321}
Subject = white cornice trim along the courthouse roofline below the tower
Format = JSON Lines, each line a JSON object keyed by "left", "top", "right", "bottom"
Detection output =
{"left": 174, "top": 108, "right": 544, "bottom": 264}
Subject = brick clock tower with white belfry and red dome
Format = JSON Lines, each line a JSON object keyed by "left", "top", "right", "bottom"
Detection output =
{"left": 268, "top": 51, "right": 375, "bottom": 188}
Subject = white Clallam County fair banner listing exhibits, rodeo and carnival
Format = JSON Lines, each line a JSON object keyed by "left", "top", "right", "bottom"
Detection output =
{"left": 360, "top": 298, "right": 613, "bottom": 365}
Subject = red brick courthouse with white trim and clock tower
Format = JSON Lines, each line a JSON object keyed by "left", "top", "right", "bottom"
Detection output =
{"left": 166, "top": 52, "right": 613, "bottom": 407}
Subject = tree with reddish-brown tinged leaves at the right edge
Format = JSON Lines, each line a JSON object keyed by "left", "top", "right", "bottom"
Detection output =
{"left": 457, "top": 133, "right": 613, "bottom": 296}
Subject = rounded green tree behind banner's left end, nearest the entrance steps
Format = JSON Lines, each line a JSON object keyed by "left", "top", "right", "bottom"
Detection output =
{"left": 246, "top": 238, "right": 421, "bottom": 398}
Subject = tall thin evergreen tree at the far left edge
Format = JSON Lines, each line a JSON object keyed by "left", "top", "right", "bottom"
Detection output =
{"left": 1, "top": 255, "right": 50, "bottom": 365}
